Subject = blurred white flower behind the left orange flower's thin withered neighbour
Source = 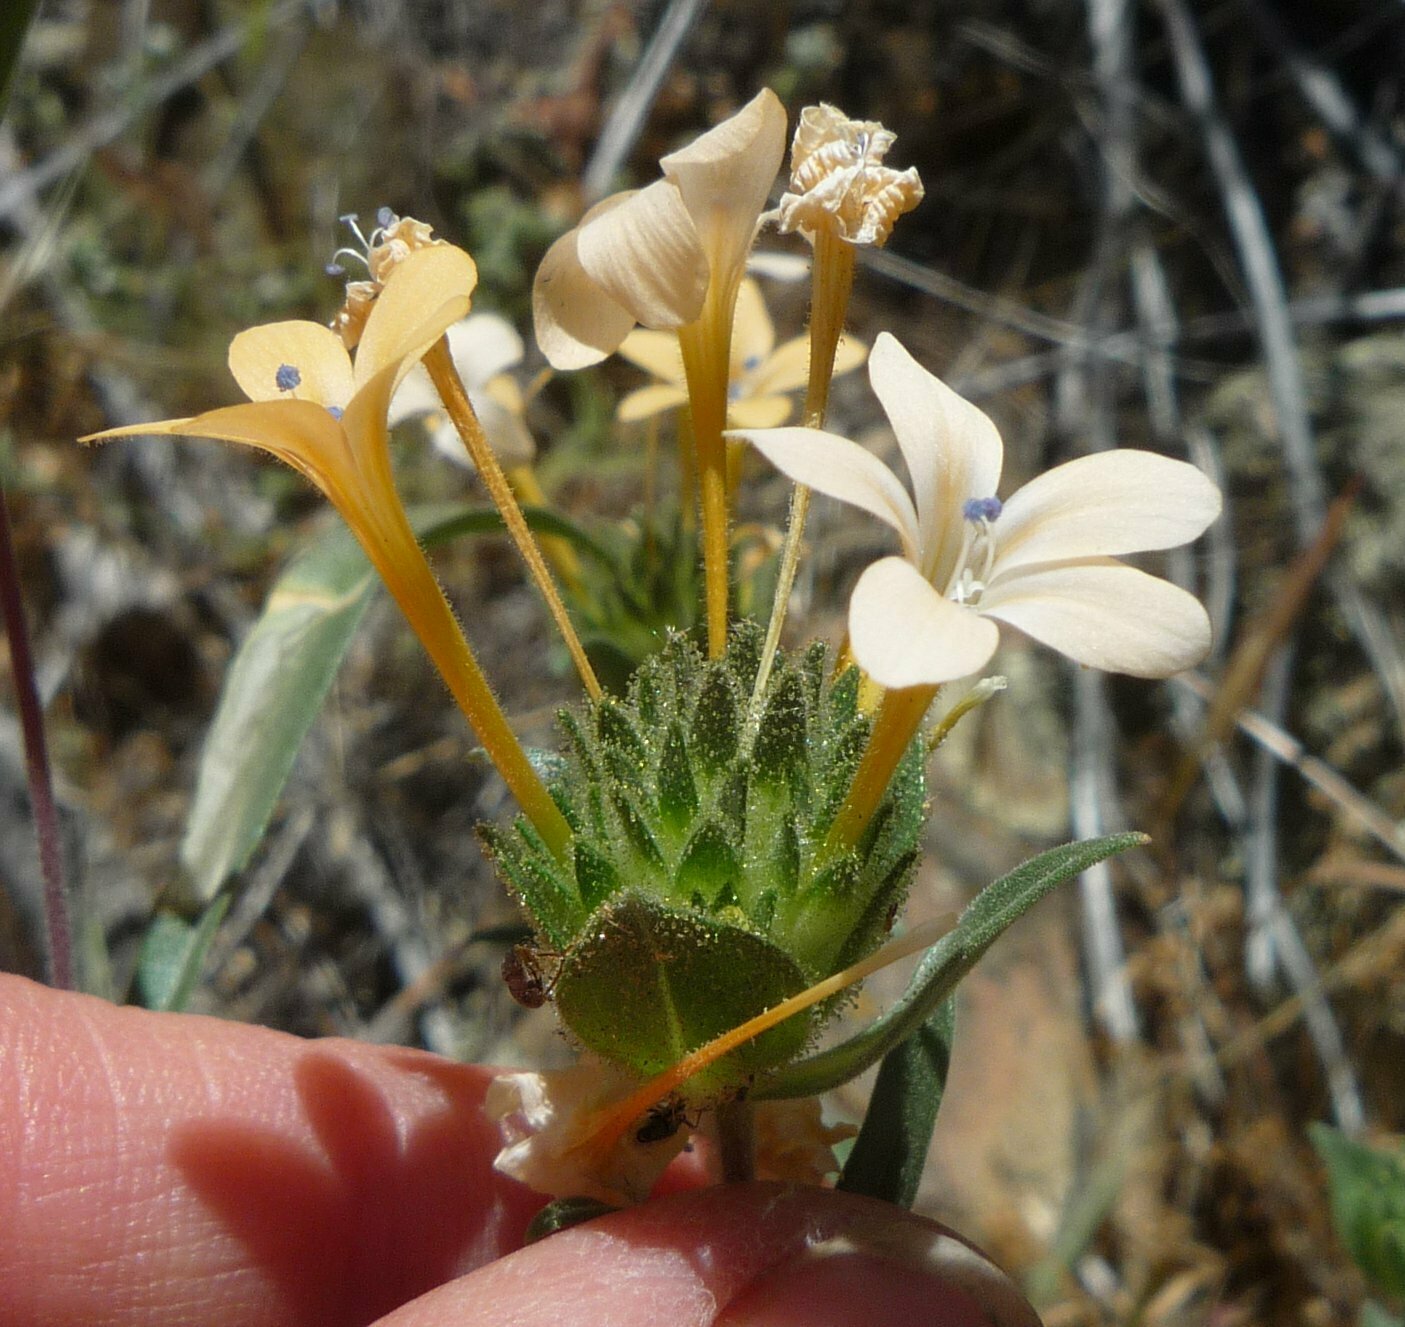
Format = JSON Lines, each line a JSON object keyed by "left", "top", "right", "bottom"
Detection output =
{"left": 389, "top": 313, "right": 537, "bottom": 470}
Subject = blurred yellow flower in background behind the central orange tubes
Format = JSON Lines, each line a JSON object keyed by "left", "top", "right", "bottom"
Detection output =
{"left": 618, "top": 277, "right": 868, "bottom": 429}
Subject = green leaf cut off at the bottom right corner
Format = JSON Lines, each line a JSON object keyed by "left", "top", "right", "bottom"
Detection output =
{"left": 1308, "top": 1125, "right": 1405, "bottom": 1299}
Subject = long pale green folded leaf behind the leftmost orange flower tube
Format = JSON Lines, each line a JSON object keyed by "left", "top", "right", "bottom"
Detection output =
{"left": 180, "top": 503, "right": 542, "bottom": 902}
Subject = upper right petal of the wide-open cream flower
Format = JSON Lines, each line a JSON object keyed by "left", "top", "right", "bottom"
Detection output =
{"left": 995, "top": 448, "right": 1221, "bottom": 572}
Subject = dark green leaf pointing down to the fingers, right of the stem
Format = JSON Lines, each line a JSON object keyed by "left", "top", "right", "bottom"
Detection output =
{"left": 839, "top": 995, "right": 957, "bottom": 1208}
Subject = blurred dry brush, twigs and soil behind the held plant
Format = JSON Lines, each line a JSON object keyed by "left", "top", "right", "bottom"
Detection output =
{"left": 0, "top": 0, "right": 1405, "bottom": 1327}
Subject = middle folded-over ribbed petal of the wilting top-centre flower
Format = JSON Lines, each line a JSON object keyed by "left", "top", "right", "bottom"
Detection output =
{"left": 576, "top": 180, "right": 707, "bottom": 329}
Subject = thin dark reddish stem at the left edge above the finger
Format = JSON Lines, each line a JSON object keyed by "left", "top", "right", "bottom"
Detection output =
{"left": 0, "top": 485, "right": 73, "bottom": 991}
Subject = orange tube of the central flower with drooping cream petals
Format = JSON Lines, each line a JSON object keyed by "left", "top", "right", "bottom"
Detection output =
{"left": 679, "top": 292, "right": 736, "bottom": 659}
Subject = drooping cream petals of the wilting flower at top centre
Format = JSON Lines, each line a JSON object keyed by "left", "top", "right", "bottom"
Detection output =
{"left": 532, "top": 89, "right": 785, "bottom": 368}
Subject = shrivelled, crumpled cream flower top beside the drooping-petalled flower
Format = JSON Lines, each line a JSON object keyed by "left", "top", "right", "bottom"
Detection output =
{"left": 776, "top": 105, "right": 923, "bottom": 245}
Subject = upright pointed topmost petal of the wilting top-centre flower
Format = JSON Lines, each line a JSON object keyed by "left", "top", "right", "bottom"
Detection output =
{"left": 659, "top": 87, "right": 785, "bottom": 290}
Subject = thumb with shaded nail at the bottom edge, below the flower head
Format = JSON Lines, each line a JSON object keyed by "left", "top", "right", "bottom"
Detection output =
{"left": 379, "top": 1184, "right": 1038, "bottom": 1327}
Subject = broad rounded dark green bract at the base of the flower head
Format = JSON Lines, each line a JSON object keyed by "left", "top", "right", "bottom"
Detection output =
{"left": 554, "top": 890, "right": 809, "bottom": 1094}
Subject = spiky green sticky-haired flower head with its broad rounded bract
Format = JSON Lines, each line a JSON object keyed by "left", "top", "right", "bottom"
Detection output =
{"left": 483, "top": 624, "right": 926, "bottom": 1098}
